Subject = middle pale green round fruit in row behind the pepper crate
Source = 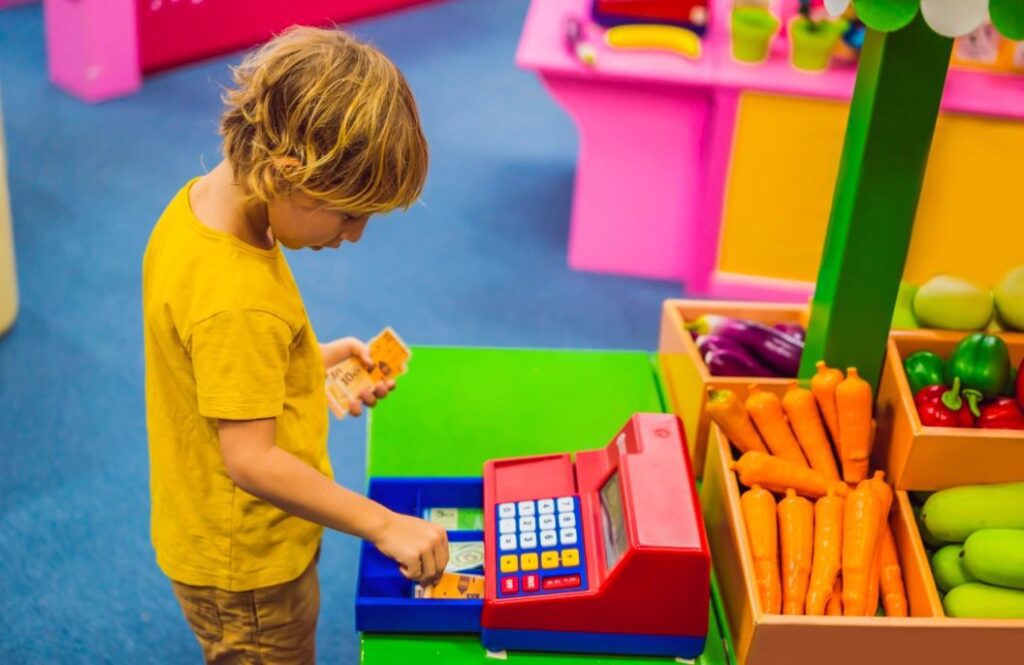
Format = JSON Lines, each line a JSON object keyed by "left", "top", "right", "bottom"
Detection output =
{"left": 913, "top": 275, "right": 992, "bottom": 330}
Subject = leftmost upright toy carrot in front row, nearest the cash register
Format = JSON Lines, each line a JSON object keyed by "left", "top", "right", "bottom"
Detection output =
{"left": 739, "top": 485, "right": 782, "bottom": 614}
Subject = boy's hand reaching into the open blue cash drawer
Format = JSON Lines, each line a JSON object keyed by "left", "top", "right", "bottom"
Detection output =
{"left": 371, "top": 512, "right": 449, "bottom": 586}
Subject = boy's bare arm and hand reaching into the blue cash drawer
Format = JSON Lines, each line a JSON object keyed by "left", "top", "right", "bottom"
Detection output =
{"left": 218, "top": 418, "right": 449, "bottom": 583}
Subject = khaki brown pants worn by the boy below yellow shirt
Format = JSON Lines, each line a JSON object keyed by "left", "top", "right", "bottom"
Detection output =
{"left": 172, "top": 552, "right": 319, "bottom": 665}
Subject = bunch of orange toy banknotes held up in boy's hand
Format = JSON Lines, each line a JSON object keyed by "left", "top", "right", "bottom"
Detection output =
{"left": 326, "top": 328, "right": 413, "bottom": 420}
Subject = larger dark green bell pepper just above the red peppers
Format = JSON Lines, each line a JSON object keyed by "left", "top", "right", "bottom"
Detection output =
{"left": 944, "top": 333, "right": 1010, "bottom": 416}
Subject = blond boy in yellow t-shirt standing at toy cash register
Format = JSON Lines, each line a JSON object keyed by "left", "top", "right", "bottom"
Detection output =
{"left": 142, "top": 28, "right": 449, "bottom": 664}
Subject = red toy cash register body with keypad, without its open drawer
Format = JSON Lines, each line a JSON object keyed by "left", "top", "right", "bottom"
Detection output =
{"left": 481, "top": 414, "right": 711, "bottom": 658}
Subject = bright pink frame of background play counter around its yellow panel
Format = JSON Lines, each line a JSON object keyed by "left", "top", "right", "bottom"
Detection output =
{"left": 516, "top": 0, "right": 1024, "bottom": 301}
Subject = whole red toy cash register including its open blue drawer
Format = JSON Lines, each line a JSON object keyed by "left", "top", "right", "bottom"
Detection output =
{"left": 355, "top": 414, "right": 711, "bottom": 658}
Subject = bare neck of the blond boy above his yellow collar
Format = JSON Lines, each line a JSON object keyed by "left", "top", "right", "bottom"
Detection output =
{"left": 189, "top": 160, "right": 274, "bottom": 249}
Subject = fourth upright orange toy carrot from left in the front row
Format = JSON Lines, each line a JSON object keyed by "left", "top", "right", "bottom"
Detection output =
{"left": 843, "top": 482, "right": 882, "bottom": 617}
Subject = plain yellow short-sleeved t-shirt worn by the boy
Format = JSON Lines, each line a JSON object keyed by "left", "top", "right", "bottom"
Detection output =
{"left": 142, "top": 180, "right": 333, "bottom": 591}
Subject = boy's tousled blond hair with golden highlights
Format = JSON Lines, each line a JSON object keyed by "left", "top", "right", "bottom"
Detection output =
{"left": 220, "top": 27, "right": 427, "bottom": 214}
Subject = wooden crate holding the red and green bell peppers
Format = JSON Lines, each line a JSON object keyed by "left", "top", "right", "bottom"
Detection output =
{"left": 871, "top": 330, "right": 1024, "bottom": 490}
